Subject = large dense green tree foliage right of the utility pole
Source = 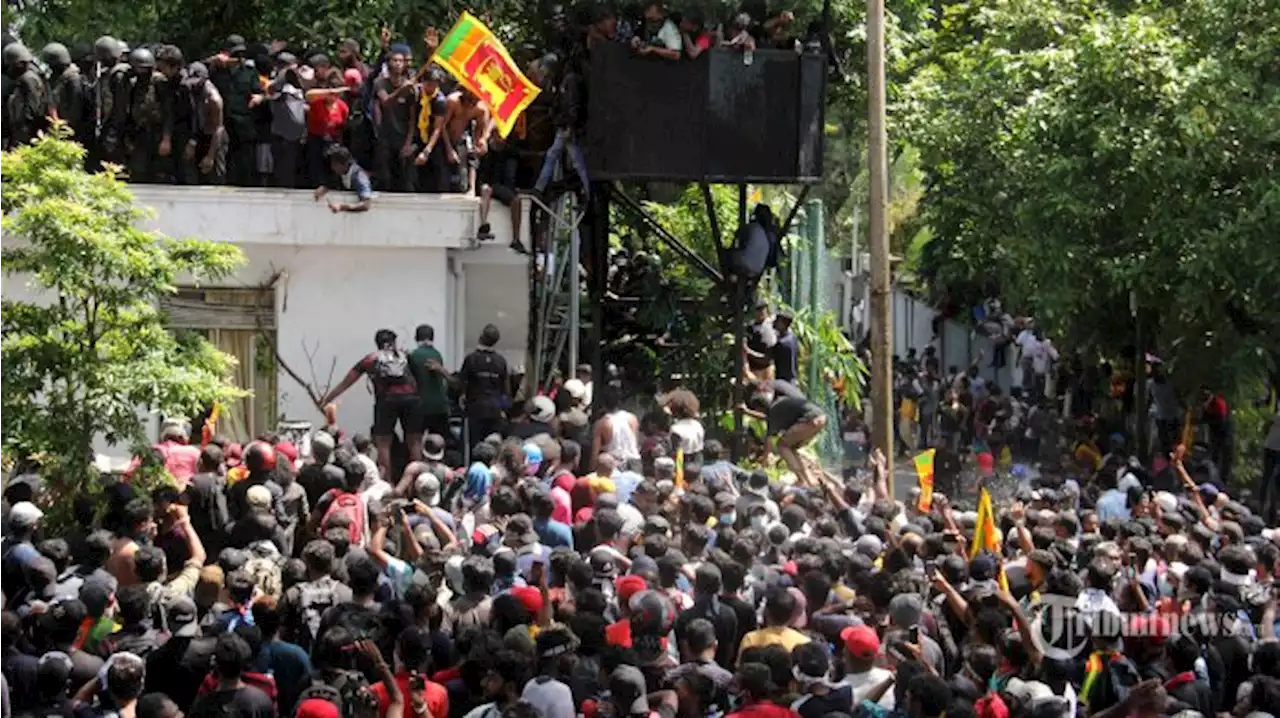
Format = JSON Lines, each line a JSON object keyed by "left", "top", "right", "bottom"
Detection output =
{"left": 897, "top": 0, "right": 1280, "bottom": 389}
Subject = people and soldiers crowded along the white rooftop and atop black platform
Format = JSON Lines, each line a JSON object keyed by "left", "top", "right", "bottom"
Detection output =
{"left": 0, "top": 0, "right": 813, "bottom": 222}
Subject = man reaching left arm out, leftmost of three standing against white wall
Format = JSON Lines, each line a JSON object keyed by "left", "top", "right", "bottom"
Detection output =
{"left": 319, "top": 329, "right": 422, "bottom": 477}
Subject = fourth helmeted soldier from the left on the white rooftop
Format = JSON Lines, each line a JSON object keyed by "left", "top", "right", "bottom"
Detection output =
{"left": 111, "top": 47, "right": 173, "bottom": 182}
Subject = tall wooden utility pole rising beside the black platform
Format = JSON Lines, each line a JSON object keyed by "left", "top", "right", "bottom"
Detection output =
{"left": 867, "top": 0, "right": 893, "bottom": 486}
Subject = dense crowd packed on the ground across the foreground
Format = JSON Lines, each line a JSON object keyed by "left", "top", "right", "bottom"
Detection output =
{"left": 0, "top": 311, "right": 1280, "bottom": 718}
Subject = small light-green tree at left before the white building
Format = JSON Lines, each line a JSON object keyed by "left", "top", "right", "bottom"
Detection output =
{"left": 0, "top": 129, "right": 243, "bottom": 491}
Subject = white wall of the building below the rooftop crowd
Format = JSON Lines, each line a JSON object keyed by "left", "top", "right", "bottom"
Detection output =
{"left": 0, "top": 187, "right": 529, "bottom": 454}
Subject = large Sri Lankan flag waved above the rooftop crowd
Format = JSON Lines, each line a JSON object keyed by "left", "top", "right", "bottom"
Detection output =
{"left": 431, "top": 12, "right": 540, "bottom": 137}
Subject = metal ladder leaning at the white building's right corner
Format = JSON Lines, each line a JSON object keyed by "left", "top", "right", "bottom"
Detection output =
{"left": 530, "top": 192, "right": 585, "bottom": 393}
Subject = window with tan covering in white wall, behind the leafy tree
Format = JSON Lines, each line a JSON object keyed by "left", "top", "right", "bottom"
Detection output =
{"left": 160, "top": 288, "right": 279, "bottom": 442}
